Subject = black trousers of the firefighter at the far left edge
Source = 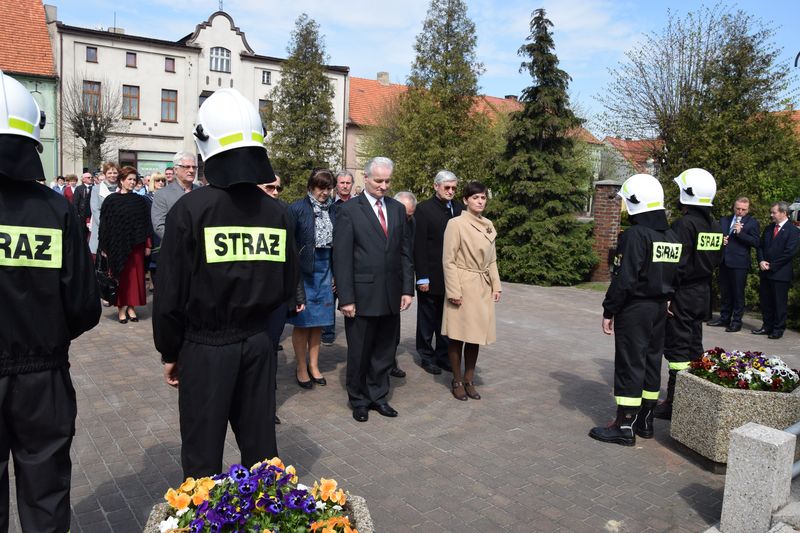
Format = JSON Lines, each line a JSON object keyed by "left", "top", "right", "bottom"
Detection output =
{"left": 0, "top": 367, "right": 78, "bottom": 533}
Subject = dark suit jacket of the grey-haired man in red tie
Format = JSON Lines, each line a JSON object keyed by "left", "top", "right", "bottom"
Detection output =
{"left": 333, "top": 195, "right": 414, "bottom": 316}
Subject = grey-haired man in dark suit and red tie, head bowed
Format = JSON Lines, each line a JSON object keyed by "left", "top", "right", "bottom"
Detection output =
{"left": 333, "top": 157, "right": 414, "bottom": 422}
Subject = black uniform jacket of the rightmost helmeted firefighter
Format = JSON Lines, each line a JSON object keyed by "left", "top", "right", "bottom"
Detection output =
{"left": 672, "top": 206, "right": 722, "bottom": 286}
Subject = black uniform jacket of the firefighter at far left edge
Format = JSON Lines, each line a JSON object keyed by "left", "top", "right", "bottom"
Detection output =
{"left": 0, "top": 176, "right": 100, "bottom": 376}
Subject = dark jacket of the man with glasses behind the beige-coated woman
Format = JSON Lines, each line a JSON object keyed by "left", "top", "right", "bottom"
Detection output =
{"left": 414, "top": 196, "right": 464, "bottom": 296}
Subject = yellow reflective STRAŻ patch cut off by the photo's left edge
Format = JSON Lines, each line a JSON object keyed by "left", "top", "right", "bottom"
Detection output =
{"left": 0, "top": 225, "right": 63, "bottom": 268}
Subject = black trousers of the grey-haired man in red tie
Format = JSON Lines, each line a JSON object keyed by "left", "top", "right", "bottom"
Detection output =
{"left": 344, "top": 315, "right": 400, "bottom": 408}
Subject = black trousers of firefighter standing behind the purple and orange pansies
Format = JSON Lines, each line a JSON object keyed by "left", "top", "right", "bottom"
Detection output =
{"left": 178, "top": 332, "right": 278, "bottom": 478}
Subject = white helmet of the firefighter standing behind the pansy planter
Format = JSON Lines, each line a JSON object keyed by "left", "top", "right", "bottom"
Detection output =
{"left": 194, "top": 89, "right": 266, "bottom": 161}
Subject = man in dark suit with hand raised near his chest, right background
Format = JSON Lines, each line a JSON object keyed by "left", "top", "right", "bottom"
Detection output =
{"left": 708, "top": 196, "right": 760, "bottom": 332}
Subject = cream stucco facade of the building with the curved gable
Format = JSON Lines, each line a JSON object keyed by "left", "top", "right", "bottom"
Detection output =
{"left": 48, "top": 7, "right": 349, "bottom": 174}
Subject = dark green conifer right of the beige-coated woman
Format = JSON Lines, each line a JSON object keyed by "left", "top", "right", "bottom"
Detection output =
{"left": 489, "top": 9, "right": 597, "bottom": 285}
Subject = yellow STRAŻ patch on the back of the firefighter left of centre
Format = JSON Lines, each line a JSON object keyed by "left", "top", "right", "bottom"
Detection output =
{"left": 203, "top": 226, "right": 286, "bottom": 263}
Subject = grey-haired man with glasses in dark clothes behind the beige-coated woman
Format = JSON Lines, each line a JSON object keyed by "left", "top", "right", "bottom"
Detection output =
{"left": 414, "top": 170, "right": 464, "bottom": 374}
